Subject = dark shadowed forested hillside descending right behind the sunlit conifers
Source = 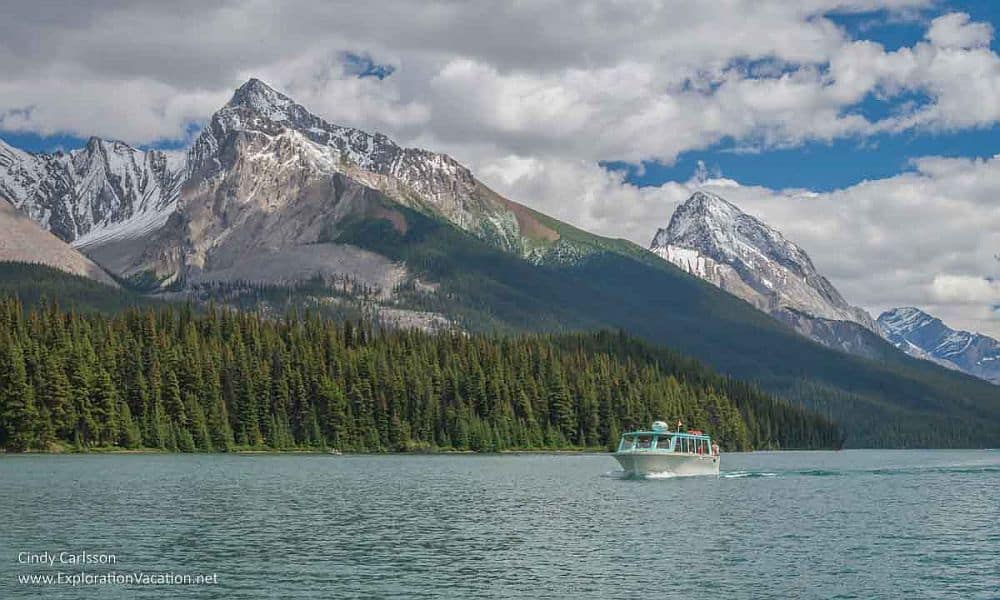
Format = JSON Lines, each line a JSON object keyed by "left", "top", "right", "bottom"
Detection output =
{"left": 334, "top": 208, "right": 1000, "bottom": 448}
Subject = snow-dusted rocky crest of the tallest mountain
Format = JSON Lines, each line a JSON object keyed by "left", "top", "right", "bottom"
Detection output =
{"left": 188, "top": 79, "right": 520, "bottom": 249}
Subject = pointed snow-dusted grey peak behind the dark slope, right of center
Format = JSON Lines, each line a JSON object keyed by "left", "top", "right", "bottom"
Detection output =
{"left": 650, "top": 191, "right": 881, "bottom": 358}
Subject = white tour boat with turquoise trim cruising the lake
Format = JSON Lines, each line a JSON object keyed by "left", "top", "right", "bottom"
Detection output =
{"left": 614, "top": 421, "right": 720, "bottom": 476}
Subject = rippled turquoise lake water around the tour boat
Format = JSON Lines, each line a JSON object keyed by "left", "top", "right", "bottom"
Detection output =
{"left": 0, "top": 450, "right": 1000, "bottom": 599}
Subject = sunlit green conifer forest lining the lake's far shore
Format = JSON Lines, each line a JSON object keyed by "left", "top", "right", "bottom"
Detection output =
{"left": 0, "top": 297, "right": 842, "bottom": 452}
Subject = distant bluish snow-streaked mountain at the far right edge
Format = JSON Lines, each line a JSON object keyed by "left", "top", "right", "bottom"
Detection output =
{"left": 878, "top": 307, "right": 1000, "bottom": 384}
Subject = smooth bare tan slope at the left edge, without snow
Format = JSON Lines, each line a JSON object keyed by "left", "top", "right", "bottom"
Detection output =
{"left": 0, "top": 199, "right": 118, "bottom": 287}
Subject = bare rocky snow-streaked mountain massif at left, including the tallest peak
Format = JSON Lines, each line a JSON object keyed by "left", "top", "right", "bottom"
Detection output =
{"left": 0, "top": 79, "right": 564, "bottom": 287}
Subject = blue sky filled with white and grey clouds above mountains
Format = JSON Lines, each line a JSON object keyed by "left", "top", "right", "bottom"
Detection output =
{"left": 0, "top": 0, "right": 1000, "bottom": 337}
